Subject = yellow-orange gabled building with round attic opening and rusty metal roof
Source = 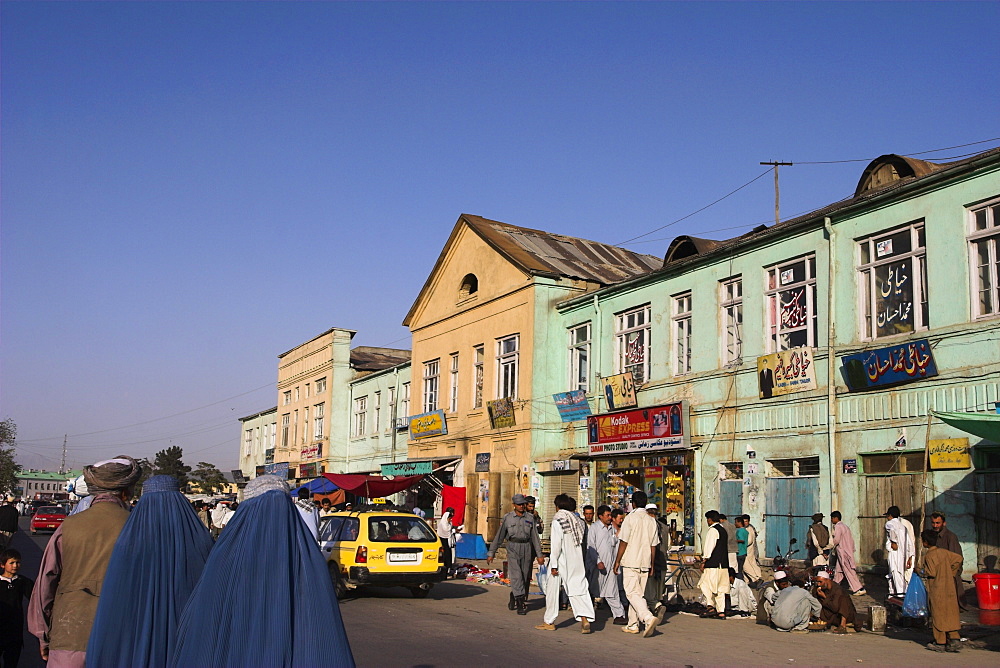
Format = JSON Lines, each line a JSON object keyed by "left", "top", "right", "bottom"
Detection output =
{"left": 403, "top": 214, "right": 662, "bottom": 536}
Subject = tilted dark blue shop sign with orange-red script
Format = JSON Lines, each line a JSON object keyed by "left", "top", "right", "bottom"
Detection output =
{"left": 842, "top": 339, "right": 937, "bottom": 391}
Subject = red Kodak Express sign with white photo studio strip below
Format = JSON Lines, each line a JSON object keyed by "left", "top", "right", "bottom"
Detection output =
{"left": 587, "top": 402, "right": 688, "bottom": 455}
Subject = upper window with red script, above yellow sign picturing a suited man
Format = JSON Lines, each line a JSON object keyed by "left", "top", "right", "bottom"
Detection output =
{"left": 765, "top": 255, "right": 816, "bottom": 353}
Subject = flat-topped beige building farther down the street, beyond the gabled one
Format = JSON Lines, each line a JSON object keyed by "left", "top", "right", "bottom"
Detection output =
{"left": 276, "top": 327, "right": 410, "bottom": 482}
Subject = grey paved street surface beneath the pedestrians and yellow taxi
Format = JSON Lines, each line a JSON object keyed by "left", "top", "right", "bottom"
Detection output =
{"left": 14, "top": 518, "right": 1000, "bottom": 668}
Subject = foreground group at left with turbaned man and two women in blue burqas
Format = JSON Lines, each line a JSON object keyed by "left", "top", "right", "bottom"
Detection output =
{"left": 0, "top": 455, "right": 354, "bottom": 668}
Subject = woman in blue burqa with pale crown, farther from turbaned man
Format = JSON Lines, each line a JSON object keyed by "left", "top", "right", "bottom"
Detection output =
{"left": 169, "top": 475, "right": 354, "bottom": 668}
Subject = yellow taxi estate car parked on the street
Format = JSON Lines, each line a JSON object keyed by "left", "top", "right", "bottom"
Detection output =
{"left": 319, "top": 508, "right": 445, "bottom": 598}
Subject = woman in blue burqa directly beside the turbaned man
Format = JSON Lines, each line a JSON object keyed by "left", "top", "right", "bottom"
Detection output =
{"left": 87, "top": 475, "right": 212, "bottom": 668}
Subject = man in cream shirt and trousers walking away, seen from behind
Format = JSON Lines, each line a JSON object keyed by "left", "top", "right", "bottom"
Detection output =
{"left": 613, "top": 490, "right": 666, "bottom": 638}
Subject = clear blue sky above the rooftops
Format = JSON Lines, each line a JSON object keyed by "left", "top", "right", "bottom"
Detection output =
{"left": 0, "top": 1, "right": 1000, "bottom": 469}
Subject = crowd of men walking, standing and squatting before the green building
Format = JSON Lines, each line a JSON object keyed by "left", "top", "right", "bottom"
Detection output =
{"left": 487, "top": 490, "right": 963, "bottom": 652}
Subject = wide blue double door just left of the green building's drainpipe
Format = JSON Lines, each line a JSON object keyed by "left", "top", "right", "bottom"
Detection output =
{"left": 761, "top": 477, "right": 820, "bottom": 559}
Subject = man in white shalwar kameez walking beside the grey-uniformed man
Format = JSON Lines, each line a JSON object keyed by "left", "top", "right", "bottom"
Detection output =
{"left": 535, "top": 494, "right": 594, "bottom": 633}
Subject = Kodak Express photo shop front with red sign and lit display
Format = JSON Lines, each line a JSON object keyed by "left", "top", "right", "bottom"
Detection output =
{"left": 587, "top": 402, "right": 696, "bottom": 545}
